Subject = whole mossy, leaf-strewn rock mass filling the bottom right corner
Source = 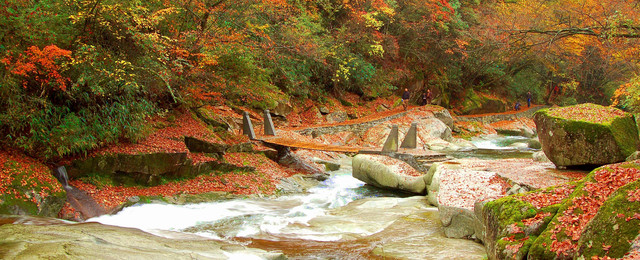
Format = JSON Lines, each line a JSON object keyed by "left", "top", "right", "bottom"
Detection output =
{"left": 481, "top": 161, "right": 640, "bottom": 259}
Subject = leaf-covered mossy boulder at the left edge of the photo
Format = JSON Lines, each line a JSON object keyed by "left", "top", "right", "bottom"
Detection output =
{"left": 0, "top": 151, "right": 67, "bottom": 217}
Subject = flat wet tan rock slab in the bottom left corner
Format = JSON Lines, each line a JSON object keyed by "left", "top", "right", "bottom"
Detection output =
{"left": 0, "top": 217, "right": 286, "bottom": 259}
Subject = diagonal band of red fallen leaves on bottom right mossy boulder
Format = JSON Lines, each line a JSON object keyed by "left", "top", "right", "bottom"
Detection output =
{"left": 550, "top": 164, "right": 640, "bottom": 256}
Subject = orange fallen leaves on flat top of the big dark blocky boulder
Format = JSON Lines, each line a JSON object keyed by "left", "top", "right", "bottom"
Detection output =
{"left": 548, "top": 104, "right": 626, "bottom": 124}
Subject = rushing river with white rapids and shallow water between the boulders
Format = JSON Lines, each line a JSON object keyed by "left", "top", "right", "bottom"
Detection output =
{"left": 88, "top": 137, "right": 531, "bottom": 259}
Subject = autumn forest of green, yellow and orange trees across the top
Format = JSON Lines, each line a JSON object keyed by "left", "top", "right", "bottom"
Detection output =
{"left": 0, "top": 0, "right": 640, "bottom": 158}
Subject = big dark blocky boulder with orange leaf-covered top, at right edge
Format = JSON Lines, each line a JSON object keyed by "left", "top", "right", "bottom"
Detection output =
{"left": 534, "top": 104, "right": 640, "bottom": 166}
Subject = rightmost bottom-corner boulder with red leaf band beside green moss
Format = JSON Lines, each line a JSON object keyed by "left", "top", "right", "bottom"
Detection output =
{"left": 529, "top": 161, "right": 640, "bottom": 259}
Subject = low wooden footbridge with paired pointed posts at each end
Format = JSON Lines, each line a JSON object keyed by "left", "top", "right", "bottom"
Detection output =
{"left": 242, "top": 110, "right": 446, "bottom": 161}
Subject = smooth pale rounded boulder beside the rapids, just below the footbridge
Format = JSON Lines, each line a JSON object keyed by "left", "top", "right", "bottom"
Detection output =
{"left": 353, "top": 154, "right": 425, "bottom": 194}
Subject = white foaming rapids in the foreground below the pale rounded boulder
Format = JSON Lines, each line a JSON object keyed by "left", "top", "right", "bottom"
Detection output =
{"left": 88, "top": 162, "right": 364, "bottom": 241}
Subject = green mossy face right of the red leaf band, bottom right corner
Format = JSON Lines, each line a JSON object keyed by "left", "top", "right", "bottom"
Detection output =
{"left": 578, "top": 181, "right": 640, "bottom": 259}
